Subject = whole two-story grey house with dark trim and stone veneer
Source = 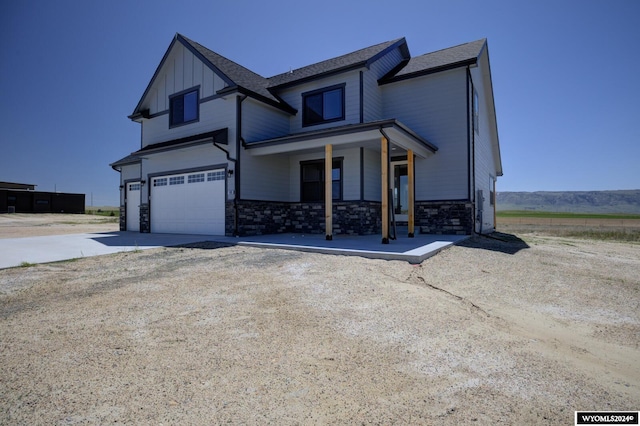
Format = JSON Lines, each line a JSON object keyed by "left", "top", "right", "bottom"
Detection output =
{"left": 111, "top": 34, "right": 502, "bottom": 242}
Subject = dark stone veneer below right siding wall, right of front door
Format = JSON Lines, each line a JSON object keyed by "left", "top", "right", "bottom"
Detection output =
{"left": 415, "top": 201, "right": 474, "bottom": 235}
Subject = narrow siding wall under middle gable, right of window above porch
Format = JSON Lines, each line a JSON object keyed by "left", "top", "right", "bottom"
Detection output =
{"left": 362, "top": 49, "right": 402, "bottom": 123}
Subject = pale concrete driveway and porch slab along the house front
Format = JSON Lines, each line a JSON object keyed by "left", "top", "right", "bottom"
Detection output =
{"left": 0, "top": 232, "right": 468, "bottom": 268}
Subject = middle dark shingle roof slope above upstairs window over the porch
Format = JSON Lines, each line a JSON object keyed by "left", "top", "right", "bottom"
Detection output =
{"left": 269, "top": 37, "right": 409, "bottom": 88}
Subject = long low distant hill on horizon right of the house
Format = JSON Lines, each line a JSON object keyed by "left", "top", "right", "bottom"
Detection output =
{"left": 497, "top": 189, "right": 640, "bottom": 214}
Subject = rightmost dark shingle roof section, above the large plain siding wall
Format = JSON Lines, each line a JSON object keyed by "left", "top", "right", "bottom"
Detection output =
{"left": 383, "top": 38, "right": 487, "bottom": 81}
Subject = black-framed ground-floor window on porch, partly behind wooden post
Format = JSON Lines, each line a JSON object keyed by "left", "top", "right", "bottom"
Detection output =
{"left": 300, "top": 158, "right": 342, "bottom": 203}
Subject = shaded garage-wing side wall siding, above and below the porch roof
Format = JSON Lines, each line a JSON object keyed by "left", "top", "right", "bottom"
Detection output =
{"left": 240, "top": 98, "right": 290, "bottom": 201}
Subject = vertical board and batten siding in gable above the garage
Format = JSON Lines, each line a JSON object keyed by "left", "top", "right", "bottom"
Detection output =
{"left": 141, "top": 43, "right": 225, "bottom": 115}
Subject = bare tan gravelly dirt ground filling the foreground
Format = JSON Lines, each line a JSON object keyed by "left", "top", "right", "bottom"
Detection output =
{"left": 0, "top": 215, "right": 640, "bottom": 425}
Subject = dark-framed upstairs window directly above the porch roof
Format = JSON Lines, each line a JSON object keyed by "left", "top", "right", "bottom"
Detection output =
{"left": 302, "top": 84, "right": 345, "bottom": 126}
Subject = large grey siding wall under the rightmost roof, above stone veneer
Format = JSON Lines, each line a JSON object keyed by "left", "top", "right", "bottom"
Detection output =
{"left": 381, "top": 68, "right": 469, "bottom": 201}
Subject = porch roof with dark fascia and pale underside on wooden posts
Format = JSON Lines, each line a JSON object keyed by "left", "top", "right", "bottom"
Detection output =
{"left": 246, "top": 119, "right": 438, "bottom": 158}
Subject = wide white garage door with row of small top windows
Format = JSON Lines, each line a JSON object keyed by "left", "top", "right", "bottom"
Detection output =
{"left": 150, "top": 169, "right": 225, "bottom": 235}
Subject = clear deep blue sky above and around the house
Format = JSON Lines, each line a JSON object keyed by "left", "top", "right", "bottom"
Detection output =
{"left": 0, "top": 0, "right": 640, "bottom": 206}
